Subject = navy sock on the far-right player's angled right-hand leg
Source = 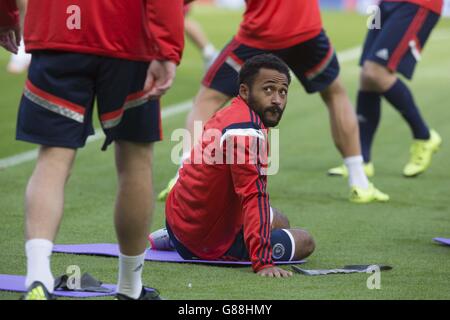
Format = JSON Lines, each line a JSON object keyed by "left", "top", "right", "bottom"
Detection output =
{"left": 384, "top": 79, "right": 430, "bottom": 140}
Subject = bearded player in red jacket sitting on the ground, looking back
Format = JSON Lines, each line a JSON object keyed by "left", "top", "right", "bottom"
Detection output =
{"left": 153, "top": 54, "right": 314, "bottom": 277}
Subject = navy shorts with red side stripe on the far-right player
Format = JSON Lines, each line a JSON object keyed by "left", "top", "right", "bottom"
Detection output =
{"left": 360, "top": 2, "right": 440, "bottom": 79}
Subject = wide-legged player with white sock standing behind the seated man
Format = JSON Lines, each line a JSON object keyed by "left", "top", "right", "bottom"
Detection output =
{"left": 158, "top": 0, "right": 389, "bottom": 203}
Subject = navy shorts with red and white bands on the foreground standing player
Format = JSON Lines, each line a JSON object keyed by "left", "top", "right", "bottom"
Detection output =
{"left": 16, "top": 51, "right": 162, "bottom": 149}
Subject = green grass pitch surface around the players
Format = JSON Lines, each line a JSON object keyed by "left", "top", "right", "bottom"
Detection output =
{"left": 0, "top": 7, "right": 450, "bottom": 300}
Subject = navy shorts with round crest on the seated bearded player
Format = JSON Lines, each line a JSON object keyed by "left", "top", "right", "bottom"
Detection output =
{"left": 166, "top": 222, "right": 295, "bottom": 261}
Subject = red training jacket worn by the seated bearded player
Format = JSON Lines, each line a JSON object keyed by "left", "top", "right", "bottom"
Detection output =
{"left": 166, "top": 98, "right": 273, "bottom": 272}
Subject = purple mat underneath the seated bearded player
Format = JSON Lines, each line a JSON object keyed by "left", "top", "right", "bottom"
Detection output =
{"left": 53, "top": 243, "right": 305, "bottom": 266}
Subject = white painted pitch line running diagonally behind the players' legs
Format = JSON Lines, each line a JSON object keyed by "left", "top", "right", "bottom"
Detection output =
{"left": 0, "top": 46, "right": 361, "bottom": 170}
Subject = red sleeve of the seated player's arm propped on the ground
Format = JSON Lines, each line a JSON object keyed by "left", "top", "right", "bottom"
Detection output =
{"left": 227, "top": 137, "right": 273, "bottom": 272}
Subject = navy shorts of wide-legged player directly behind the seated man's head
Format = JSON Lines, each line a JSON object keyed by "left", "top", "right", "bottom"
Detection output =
{"left": 203, "top": 30, "right": 339, "bottom": 97}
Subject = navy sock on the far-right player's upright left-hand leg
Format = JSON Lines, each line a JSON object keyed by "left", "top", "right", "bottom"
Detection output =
{"left": 356, "top": 91, "right": 381, "bottom": 163}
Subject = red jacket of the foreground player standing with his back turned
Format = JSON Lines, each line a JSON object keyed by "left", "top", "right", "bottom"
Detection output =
{"left": 0, "top": 0, "right": 184, "bottom": 64}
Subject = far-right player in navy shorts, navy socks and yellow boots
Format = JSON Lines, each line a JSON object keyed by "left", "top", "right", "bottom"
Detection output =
{"left": 329, "top": 0, "right": 443, "bottom": 177}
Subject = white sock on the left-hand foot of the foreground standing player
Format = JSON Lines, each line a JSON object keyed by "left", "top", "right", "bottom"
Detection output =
{"left": 25, "top": 239, "right": 55, "bottom": 293}
